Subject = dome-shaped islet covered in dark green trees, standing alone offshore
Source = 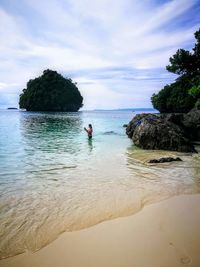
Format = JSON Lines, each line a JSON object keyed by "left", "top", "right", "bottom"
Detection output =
{"left": 19, "top": 69, "right": 83, "bottom": 112}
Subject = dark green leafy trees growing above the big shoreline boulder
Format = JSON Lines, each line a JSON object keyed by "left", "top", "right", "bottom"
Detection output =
{"left": 151, "top": 29, "right": 200, "bottom": 113}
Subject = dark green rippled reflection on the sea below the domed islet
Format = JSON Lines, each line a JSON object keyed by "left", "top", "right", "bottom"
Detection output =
{"left": 20, "top": 113, "right": 82, "bottom": 154}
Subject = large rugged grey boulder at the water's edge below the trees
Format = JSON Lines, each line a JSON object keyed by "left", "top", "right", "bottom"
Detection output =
{"left": 126, "top": 113, "right": 198, "bottom": 152}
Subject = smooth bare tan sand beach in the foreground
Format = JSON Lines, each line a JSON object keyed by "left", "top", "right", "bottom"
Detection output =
{"left": 0, "top": 195, "right": 200, "bottom": 267}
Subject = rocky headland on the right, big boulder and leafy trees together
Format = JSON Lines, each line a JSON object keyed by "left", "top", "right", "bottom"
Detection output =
{"left": 126, "top": 29, "right": 200, "bottom": 152}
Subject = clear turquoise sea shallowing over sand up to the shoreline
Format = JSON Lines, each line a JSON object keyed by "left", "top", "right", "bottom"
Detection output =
{"left": 0, "top": 111, "right": 200, "bottom": 258}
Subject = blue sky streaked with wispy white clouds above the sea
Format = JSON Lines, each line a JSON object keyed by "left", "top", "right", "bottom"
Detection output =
{"left": 0, "top": 0, "right": 200, "bottom": 109}
